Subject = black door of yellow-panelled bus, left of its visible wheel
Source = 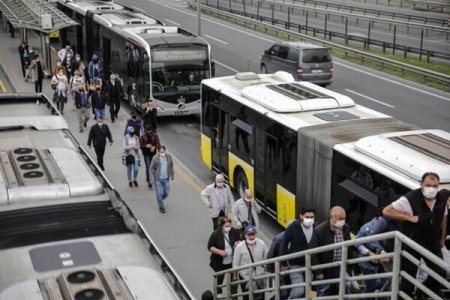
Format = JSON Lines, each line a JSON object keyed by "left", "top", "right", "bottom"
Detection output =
{"left": 211, "top": 105, "right": 228, "bottom": 174}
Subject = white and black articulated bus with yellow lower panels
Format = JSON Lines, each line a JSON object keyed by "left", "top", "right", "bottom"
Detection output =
{"left": 201, "top": 72, "right": 450, "bottom": 228}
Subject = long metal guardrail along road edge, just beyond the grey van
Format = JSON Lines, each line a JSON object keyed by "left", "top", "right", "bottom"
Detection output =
{"left": 191, "top": 1, "right": 450, "bottom": 91}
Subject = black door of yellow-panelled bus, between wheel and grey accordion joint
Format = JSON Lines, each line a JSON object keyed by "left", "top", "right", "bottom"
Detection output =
{"left": 254, "top": 129, "right": 278, "bottom": 213}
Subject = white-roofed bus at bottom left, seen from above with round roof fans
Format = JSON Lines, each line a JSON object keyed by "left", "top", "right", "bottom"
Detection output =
{"left": 0, "top": 94, "right": 194, "bottom": 300}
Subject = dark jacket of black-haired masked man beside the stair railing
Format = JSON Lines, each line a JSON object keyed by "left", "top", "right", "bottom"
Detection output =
{"left": 280, "top": 220, "right": 314, "bottom": 266}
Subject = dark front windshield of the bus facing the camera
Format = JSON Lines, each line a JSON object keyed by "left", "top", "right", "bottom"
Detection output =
{"left": 152, "top": 49, "right": 210, "bottom": 103}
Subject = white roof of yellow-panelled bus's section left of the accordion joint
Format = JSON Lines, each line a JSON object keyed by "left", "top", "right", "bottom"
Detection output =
{"left": 202, "top": 72, "right": 390, "bottom": 131}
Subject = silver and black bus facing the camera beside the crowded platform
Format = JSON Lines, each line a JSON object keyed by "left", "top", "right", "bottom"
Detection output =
{"left": 58, "top": 0, "right": 212, "bottom": 116}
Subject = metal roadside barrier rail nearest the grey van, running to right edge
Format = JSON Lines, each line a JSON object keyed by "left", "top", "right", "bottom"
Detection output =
{"left": 192, "top": 0, "right": 450, "bottom": 90}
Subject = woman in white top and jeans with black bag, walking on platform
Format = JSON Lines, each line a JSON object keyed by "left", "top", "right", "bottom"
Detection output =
{"left": 123, "top": 126, "right": 140, "bottom": 187}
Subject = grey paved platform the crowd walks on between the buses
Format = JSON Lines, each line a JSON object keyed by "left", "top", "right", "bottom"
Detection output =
{"left": 0, "top": 24, "right": 213, "bottom": 298}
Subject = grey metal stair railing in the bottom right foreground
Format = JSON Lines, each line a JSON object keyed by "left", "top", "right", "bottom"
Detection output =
{"left": 214, "top": 231, "right": 450, "bottom": 300}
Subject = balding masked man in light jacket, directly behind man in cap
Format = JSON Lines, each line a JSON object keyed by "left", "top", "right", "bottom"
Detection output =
{"left": 232, "top": 189, "right": 261, "bottom": 230}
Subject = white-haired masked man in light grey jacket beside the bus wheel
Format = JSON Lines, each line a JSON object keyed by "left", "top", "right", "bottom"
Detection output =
{"left": 200, "top": 174, "right": 234, "bottom": 230}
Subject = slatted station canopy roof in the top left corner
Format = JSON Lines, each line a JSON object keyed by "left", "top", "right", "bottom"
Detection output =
{"left": 0, "top": 0, "right": 79, "bottom": 34}
